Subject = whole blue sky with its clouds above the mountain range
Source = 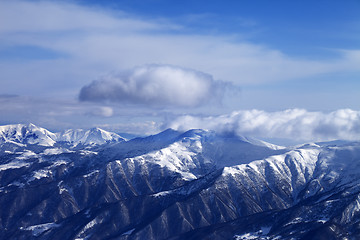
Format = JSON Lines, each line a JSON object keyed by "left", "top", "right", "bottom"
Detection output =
{"left": 0, "top": 0, "right": 360, "bottom": 140}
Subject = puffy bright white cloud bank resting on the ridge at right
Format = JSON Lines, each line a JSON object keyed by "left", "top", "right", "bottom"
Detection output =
{"left": 167, "top": 109, "right": 360, "bottom": 141}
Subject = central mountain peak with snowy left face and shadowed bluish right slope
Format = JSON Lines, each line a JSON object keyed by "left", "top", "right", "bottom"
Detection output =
{"left": 107, "top": 129, "right": 284, "bottom": 180}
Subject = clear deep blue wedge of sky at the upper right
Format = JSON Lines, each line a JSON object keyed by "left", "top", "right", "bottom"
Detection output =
{"left": 78, "top": 0, "right": 360, "bottom": 53}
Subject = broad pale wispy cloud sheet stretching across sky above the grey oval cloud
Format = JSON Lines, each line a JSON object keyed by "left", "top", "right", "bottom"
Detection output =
{"left": 0, "top": 0, "right": 360, "bottom": 98}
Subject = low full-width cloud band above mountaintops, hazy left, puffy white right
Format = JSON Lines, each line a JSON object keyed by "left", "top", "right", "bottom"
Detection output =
{"left": 0, "top": 95, "right": 360, "bottom": 143}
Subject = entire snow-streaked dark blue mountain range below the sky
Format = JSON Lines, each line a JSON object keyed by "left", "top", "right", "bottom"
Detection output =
{"left": 0, "top": 126, "right": 360, "bottom": 240}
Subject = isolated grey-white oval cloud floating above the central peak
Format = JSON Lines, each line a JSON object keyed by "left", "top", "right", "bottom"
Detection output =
{"left": 79, "top": 65, "right": 223, "bottom": 107}
